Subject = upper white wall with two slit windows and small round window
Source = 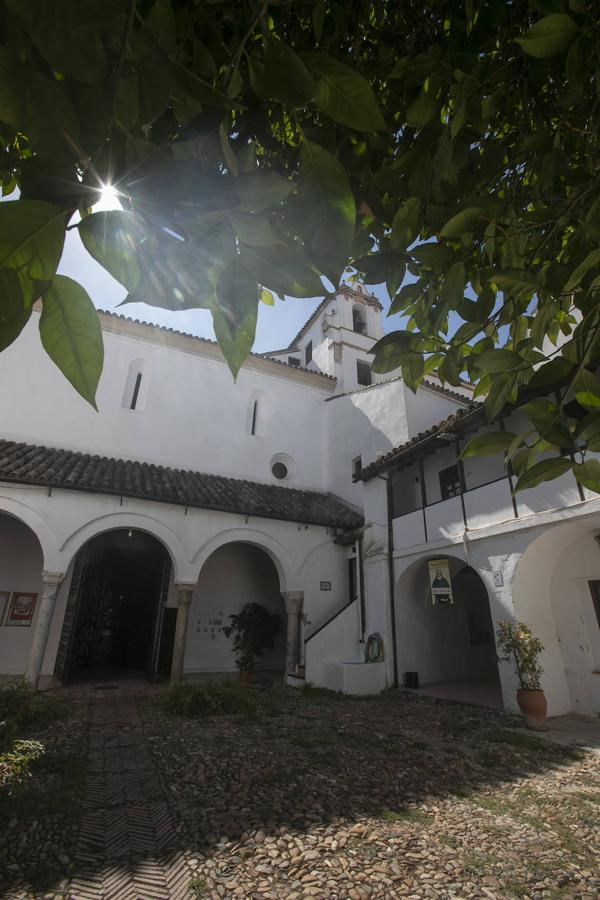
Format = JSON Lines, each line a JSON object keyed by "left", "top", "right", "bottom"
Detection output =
{"left": 0, "top": 313, "right": 334, "bottom": 489}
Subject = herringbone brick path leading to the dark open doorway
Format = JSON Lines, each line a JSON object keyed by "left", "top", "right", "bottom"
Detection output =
{"left": 66, "top": 692, "right": 191, "bottom": 900}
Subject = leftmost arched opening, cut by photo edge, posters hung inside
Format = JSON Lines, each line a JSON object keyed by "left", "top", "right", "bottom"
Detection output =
{"left": 0, "top": 513, "right": 44, "bottom": 676}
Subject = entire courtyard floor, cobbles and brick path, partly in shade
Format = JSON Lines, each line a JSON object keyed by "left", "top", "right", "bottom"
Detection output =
{"left": 0, "top": 685, "right": 600, "bottom": 900}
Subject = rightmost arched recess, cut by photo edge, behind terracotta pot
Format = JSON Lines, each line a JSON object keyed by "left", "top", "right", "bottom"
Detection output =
{"left": 513, "top": 517, "right": 600, "bottom": 716}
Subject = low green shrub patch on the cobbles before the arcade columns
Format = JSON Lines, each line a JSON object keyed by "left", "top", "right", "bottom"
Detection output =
{"left": 161, "top": 681, "right": 263, "bottom": 719}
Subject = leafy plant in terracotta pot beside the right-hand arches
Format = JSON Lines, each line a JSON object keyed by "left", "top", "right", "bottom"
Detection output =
{"left": 496, "top": 621, "right": 547, "bottom": 731}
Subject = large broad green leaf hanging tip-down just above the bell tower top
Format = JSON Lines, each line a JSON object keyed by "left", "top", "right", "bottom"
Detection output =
{"left": 298, "top": 140, "right": 356, "bottom": 286}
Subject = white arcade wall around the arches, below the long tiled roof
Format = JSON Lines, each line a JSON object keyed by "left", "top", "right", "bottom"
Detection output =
{"left": 0, "top": 485, "right": 348, "bottom": 674}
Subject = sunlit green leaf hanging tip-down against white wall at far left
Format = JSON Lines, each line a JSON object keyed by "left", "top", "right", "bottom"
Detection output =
{"left": 40, "top": 275, "right": 104, "bottom": 409}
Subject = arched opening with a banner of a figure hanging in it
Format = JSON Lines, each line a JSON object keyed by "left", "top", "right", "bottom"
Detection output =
{"left": 396, "top": 557, "right": 503, "bottom": 708}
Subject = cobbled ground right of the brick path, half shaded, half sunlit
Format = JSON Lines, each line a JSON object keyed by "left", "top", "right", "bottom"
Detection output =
{"left": 143, "top": 689, "right": 600, "bottom": 900}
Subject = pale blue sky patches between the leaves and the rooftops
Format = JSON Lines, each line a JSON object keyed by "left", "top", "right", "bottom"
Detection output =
{"left": 58, "top": 228, "right": 399, "bottom": 353}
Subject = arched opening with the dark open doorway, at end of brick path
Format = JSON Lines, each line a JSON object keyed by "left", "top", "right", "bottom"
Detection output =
{"left": 55, "top": 528, "right": 177, "bottom": 681}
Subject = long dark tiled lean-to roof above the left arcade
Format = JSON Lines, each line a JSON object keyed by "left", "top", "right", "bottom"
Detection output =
{"left": 0, "top": 439, "right": 362, "bottom": 529}
